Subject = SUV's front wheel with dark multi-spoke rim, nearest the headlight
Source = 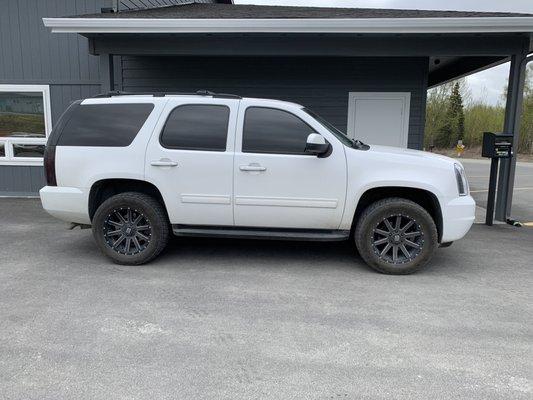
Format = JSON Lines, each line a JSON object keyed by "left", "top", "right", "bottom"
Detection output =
{"left": 354, "top": 198, "right": 438, "bottom": 275}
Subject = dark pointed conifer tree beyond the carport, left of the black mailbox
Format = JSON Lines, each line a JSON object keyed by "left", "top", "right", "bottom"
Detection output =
{"left": 435, "top": 82, "right": 465, "bottom": 148}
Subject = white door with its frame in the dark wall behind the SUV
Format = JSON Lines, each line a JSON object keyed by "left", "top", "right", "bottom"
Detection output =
{"left": 348, "top": 92, "right": 411, "bottom": 147}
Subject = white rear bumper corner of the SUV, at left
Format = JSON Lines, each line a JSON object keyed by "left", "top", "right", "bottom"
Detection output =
{"left": 39, "top": 186, "right": 91, "bottom": 225}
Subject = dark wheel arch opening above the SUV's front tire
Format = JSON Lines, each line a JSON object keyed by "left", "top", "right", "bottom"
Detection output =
{"left": 352, "top": 186, "right": 443, "bottom": 243}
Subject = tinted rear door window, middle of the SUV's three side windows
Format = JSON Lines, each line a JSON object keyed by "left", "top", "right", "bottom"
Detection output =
{"left": 160, "top": 104, "right": 230, "bottom": 151}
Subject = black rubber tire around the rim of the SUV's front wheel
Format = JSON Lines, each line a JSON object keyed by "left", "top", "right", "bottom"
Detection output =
{"left": 354, "top": 198, "right": 438, "bottom": 275}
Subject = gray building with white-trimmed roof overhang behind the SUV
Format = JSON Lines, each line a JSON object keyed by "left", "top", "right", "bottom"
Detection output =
{"left": 0, "top": 0, "right": 533, "bottom": 219}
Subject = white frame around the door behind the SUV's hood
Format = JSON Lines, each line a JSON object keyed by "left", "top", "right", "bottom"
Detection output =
{"left": 347, "top": 92, "right": 411, "bottom": 148}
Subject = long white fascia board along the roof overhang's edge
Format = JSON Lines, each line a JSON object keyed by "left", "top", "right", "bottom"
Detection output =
{"left": 43, "top": 17, "right": 533, "bottom": 34}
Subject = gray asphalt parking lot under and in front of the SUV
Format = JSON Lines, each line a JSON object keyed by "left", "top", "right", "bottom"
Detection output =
{"left": 0, "top": 198, "right": 533, "bottom": 400}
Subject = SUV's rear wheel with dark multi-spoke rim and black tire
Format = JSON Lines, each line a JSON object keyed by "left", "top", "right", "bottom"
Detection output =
{"left": 93, "top": 192, "right": 169, "bottom": 265}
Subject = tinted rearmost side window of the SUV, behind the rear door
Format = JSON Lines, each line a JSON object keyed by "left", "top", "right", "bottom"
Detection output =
{"left": 57, "top": 104, "right": 154, "bottom": 147}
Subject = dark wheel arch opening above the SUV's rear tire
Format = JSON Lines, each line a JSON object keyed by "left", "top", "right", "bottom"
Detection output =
{"left": 88, "top": 178, "right": 168, "bottom": 221}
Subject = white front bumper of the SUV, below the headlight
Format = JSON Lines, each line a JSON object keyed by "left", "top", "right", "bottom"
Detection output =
{"left": 441, "top": 196, "right": 476, "bottom": 243}
